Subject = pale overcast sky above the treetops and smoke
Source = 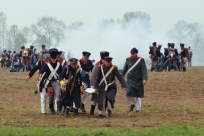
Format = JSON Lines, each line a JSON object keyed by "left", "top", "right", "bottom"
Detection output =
{"left": 0, "top": 0, "right": 204, "bottom": 34}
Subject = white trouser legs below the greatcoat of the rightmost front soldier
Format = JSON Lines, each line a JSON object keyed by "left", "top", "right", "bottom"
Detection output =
{"left": 127, "top": 96, "right": 142, "bottom": 111}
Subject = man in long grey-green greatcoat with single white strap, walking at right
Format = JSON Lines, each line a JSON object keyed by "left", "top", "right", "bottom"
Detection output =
{"left": 122, "top": 48, "right": 147, "bottom": 112}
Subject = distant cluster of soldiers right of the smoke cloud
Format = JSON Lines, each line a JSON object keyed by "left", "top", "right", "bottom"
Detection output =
{"left": 149, "top": 42, "right": 192, "bottom": 72}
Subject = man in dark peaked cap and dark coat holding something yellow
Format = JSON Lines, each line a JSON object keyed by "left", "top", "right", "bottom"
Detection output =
{"left": 59, "top": 58, "right": 82, "bottom": 117}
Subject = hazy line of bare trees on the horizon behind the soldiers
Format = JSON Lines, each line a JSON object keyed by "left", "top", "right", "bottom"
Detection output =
{"left": 0, "top": 11, "right": 204, "bottom": 55}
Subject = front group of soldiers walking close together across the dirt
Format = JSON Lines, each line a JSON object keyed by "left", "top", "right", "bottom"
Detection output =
{"left": 26, "top": 48, "right": 147, "bottom": 118}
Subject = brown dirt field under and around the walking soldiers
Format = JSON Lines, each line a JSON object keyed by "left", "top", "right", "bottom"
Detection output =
{"left": 0, "top": 67, "right": 204, "bottom": 129}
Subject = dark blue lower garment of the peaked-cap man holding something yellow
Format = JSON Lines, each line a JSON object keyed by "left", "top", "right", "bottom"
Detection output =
{"left": 61, "top": 85, "right": 81, "bottom": 109}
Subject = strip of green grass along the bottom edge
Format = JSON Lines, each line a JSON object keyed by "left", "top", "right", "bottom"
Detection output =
{"left": 0, "top": 124, "right": 204, "bottom": 136}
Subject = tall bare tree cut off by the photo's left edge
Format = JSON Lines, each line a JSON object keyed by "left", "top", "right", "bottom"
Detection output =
{"left": 0, "top": 12, "right": 7, "bottom": 48}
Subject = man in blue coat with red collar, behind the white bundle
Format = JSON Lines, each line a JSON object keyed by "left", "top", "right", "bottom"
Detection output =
{"left": 79, "top": 51, "right": 93, "bottom": 112}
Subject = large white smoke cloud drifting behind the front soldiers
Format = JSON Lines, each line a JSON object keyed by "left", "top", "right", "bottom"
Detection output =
{"left": 58, "top": 20, "right": 158, "bottom": 69}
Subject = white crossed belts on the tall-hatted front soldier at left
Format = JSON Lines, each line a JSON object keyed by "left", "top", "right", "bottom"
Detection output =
{"left": 45, "top": 62, "right": 60, "bottom": 88}
